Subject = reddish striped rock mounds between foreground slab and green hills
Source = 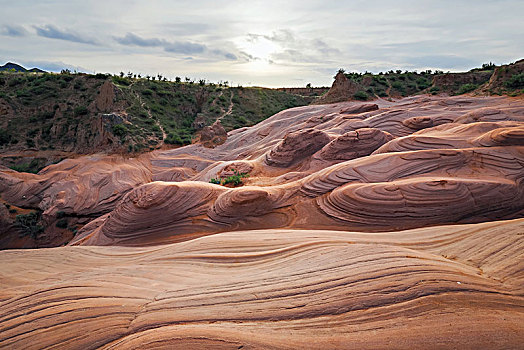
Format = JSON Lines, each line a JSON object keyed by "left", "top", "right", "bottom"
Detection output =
{"left": 0, "top": 96, "right": 524, "bottom": 246}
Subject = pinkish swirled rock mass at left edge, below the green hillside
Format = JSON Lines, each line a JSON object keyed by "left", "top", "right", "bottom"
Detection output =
{"left": 0, "top": 155, "right": 151, "bottom": 221}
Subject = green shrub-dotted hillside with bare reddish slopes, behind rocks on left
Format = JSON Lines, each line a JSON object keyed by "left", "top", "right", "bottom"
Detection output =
{"left": 0, "top": 70, "right": 308, "bottom": 159}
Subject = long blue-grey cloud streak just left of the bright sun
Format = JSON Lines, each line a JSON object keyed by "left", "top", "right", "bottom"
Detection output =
{"left": 114, "top": 33, "right": 237, "bottom": 60}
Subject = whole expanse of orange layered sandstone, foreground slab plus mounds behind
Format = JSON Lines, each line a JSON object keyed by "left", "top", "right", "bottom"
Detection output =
{"left": 0, "top": 95, "right": 524, "bottom": 349}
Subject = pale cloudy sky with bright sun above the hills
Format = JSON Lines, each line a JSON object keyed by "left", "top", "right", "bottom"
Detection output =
{"left": 0, "top": 0, "right": 524, "bottom": 87}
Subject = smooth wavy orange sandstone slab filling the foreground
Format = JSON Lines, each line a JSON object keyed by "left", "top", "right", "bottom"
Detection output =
{"left": 0, "top": 220, "right": 524, "bottom": 349}
